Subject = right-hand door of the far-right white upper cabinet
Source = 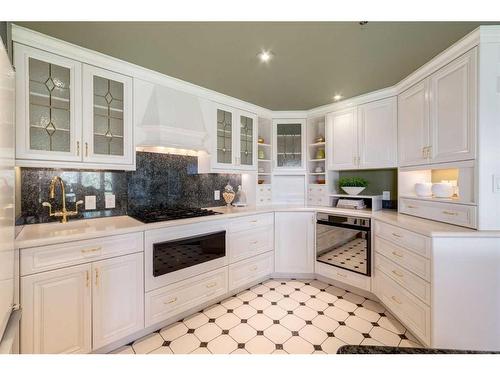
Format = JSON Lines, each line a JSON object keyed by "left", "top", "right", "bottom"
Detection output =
{"left": 430, "top": 49, "right": 477, "bottom": 163}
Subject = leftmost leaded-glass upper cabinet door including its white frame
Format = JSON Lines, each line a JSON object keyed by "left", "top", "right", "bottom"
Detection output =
{"left": 14, "top": 43, "right": 82, "bottom": 161}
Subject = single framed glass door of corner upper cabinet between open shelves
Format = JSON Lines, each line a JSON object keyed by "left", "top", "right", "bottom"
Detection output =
{"left": 273, "top": 119, "right": 306, "bottom": 172}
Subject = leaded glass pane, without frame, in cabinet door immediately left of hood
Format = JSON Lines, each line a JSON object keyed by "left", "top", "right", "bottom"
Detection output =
{"left": 94, "top": 76, "right": 124, "bottom": 156}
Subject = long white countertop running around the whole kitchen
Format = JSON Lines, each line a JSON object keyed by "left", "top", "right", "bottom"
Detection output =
{"left": 16, "top": 205, "right": 492, "bottom": 248}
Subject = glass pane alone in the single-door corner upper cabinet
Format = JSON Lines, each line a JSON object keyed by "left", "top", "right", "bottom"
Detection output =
{"left": 276, "top": 124, "right": 302, "bottom": 168}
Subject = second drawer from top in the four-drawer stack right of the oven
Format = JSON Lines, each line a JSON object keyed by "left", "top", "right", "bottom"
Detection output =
{"left": 375, "top": 236, "right": 431, "bottom": 281}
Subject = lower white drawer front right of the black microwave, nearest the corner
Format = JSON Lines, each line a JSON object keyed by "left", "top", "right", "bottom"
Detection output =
{"left": 229, "top": 251, "right": 274, "bottom": 290}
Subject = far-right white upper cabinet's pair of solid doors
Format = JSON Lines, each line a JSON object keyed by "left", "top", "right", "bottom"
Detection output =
{"left": 398, "top": 47, "right": 477, "bottom": 166}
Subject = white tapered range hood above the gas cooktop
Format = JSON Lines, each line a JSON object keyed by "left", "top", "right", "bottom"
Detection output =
{"left": 134, "top": 79, "right": 208, "bottom": 151}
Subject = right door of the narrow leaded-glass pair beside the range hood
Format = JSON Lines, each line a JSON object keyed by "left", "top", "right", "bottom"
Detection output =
{"left": 236, "top": 112, "right": 258, "bottom": 169}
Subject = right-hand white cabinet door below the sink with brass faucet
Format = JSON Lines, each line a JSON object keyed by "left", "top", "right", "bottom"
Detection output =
{"left": 92, "top": 253, "right": 144, "bottom": 350}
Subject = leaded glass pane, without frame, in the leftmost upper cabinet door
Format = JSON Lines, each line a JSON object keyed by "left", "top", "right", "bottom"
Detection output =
{"left": 29, "top": 57, "right": 71, "bottom": 152}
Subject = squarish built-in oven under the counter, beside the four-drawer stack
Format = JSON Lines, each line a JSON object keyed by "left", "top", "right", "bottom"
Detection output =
{"left": 316, "top": 212, "right": 371, "bottom": 276}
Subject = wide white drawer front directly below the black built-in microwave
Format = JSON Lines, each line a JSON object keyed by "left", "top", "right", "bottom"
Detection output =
{"left": 145, "top": 267, "right": 228, "bottom": 326}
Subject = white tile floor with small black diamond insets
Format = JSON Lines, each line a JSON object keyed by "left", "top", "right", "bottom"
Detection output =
{"left": 112, "top": 279, "right": 420, "bottom": 354}
